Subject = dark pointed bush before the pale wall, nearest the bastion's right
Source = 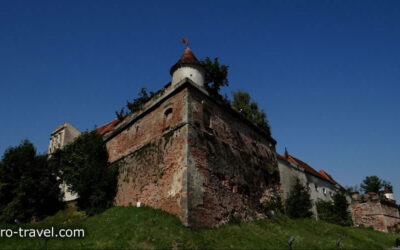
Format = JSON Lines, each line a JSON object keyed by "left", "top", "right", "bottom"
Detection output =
{"left": 285, "top": 178, "right": 312, "bottom": 218}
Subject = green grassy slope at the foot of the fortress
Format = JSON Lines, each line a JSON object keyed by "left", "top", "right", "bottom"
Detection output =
{"left": 0, "top": 207, "right": 400, "bottom": 249}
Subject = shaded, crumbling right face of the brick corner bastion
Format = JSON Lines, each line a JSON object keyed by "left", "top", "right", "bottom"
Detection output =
{"left": 188, "top": 87, "right": 280, "bottom": 226}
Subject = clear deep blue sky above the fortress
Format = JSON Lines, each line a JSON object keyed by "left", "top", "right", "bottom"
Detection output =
{"left": 0, "top": 0, "right": 400, "bottom": 200}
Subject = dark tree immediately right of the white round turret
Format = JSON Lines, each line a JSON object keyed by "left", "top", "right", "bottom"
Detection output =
{"left": 200, "top": 57, "right": 229, "bottom": 96}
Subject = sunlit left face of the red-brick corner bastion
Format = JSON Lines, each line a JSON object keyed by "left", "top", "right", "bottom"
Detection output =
{"left": 106, "top": 89, "right": 188, "bottom": 221}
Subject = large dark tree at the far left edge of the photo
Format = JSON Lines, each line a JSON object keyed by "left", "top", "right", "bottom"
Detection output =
{"left": 0, "top": 140, "right": 63, "bottom": 223}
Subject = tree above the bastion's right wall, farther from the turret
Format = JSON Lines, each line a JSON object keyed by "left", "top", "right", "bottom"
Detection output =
{"left": 232, "top": 91, "right": 271, "bottom": 135}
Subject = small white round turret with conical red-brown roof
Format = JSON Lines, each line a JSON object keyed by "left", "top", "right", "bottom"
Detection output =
{"left": 169, "top": 46, "right": 205, "bottom": 87}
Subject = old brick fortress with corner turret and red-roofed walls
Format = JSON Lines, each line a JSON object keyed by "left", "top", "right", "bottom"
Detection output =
{"left": 49, "top": 46, "right": 400, "bottom": 229}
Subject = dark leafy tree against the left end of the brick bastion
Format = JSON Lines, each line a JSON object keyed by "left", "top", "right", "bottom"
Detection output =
{"left": 51, "top": 132, "right": 118, "bottom": 214}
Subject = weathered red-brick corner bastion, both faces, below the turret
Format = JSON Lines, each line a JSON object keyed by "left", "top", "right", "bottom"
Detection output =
{"left": 106, "top": 82, "right": 280, "bottom": 226}
